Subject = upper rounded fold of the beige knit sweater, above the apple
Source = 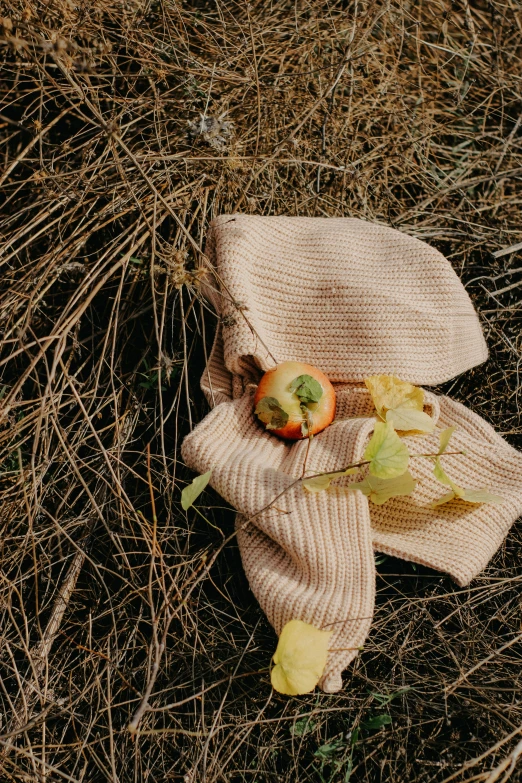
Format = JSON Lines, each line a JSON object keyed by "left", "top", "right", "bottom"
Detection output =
{"left": 201, "top": 214, "right": 488, "bottom": 385}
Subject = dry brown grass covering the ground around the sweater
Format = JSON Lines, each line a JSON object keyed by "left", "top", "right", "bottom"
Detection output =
{"left": 0, "top": 0, "right": 522, "bottom": 783}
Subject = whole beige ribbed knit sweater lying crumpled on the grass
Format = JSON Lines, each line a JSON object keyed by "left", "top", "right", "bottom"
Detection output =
{"left": 182, "top": 214, "right": 522, "bottom": 692}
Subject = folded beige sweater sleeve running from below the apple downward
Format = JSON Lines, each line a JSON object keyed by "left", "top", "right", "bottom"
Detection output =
{"left": 182, "top": 393, "right": 375, "bottom": 692}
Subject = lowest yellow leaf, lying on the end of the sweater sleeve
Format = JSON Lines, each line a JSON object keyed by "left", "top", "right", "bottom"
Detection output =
{"left": 270, "top": 620, "right": 333, "bottom": 696}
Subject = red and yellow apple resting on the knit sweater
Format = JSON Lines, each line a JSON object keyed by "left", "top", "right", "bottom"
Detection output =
{"left": 254, "top": 362, "right": 335, "bottom": 440}
